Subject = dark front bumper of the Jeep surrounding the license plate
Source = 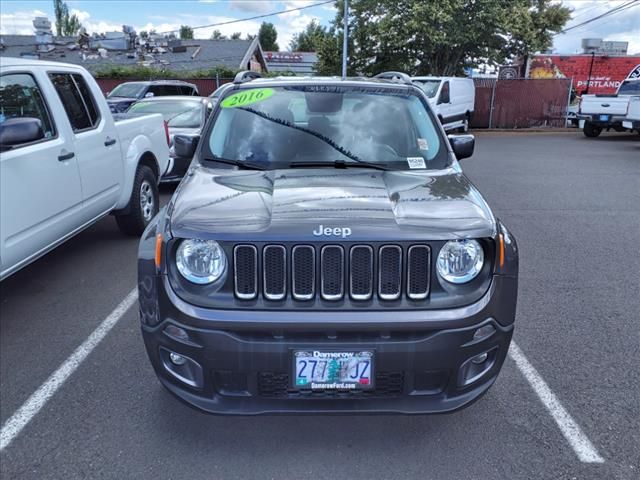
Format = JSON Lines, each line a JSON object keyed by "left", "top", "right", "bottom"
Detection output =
{"left": 142, "top": 276, "right": 517, "bottom": 414}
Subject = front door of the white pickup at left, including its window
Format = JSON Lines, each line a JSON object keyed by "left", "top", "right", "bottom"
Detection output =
{"left": 0, "top": 70, "right": 82, "bottom": 278}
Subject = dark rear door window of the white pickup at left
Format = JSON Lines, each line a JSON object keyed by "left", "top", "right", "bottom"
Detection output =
{"left": 49, "top": 73, "right": 100, "bottom": 132}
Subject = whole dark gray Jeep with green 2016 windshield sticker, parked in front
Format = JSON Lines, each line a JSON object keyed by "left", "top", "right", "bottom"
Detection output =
{"left": 138, "top": 72, "right": 518, "bottom": 414}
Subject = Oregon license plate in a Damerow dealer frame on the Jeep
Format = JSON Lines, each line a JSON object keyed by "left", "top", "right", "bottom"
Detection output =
{"left": 293, "top": 350, "right": 375, "bottom": 390}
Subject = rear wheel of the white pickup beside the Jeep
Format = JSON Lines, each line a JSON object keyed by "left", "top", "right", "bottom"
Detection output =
{"left": 116, "top": 165, "right": 160, "bottom": 236}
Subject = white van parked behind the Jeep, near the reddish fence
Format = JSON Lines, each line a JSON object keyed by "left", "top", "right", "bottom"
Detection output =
{"left": 411, "top": 77, "right": 476, "bottom": 132}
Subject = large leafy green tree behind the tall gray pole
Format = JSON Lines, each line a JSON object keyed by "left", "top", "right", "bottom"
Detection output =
{"left": 319, "top": 0, "right": 571, "bottom": 75}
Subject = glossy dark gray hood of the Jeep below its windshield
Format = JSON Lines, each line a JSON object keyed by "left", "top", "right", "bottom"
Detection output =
{"left": 169, "top": 165, "right": 496, "bottom": 241}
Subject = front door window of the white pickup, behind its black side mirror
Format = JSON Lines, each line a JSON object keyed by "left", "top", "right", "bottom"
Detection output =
{"left": 0, "top": 73, "right": 56, "bottom": 139}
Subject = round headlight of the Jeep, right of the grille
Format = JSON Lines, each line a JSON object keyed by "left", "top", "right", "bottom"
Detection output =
{"left": 437, "top": 240, "right": 484, "bottom": 284}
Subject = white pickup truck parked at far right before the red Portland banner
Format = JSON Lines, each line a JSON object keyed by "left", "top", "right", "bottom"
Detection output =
{"left": 578, "top": 78, "right": 640, "bottom": 137}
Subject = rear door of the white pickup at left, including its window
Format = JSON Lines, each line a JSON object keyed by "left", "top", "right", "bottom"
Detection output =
{"left": 49, "top": 71, "right": 123, "bottom": 221}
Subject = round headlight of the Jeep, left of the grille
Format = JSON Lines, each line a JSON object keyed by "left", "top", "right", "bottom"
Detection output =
{"left": 176, "top": 239, "right": 227, "bottom": 285}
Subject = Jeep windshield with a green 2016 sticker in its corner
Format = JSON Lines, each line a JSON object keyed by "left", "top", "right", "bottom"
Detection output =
{"left": 202, "top": 85, "right": 450, "bottom": 170}
